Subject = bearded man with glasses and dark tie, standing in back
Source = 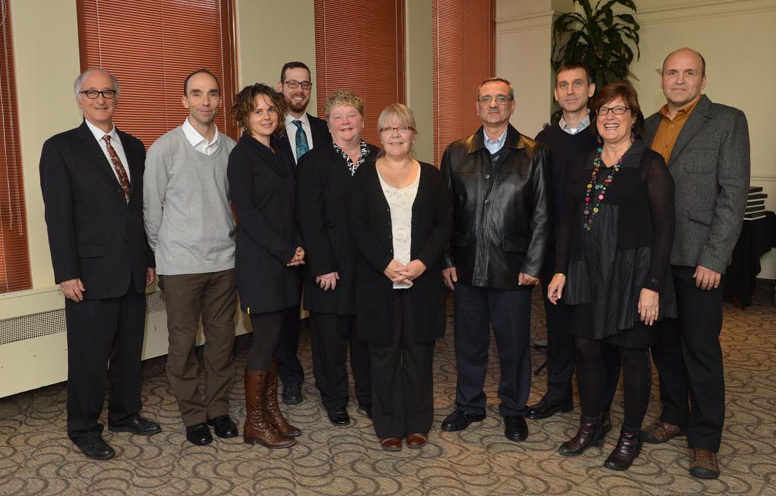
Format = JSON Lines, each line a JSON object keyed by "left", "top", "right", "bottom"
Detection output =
{"left": 277, "top": 62, "right": 331, "bottom": 405}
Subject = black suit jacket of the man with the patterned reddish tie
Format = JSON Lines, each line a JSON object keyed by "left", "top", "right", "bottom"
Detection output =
{"left": 40, "top": 121, "right": 154, "bottom": 299}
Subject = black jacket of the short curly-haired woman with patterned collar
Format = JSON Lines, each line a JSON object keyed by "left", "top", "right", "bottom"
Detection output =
{"left": 296, "top": 140, "right": 379, "bottom": 315}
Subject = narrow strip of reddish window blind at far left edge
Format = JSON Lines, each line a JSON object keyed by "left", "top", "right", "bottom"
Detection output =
{"left": 0, "top": 0, "right": 32, "bottom": 293}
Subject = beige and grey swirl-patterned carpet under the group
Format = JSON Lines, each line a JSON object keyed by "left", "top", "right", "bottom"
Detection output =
{"left": 0, "top": 290, "right": 776, "bottom": 496}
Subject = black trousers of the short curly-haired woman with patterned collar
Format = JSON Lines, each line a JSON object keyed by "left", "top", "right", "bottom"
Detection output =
{"left": 310, "top": 312, "right": 372, "bottom": 411}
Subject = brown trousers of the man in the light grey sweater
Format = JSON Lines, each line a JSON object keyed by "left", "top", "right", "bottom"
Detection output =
{"left": 159, "top": 269, "right": 237, "bottom": 427}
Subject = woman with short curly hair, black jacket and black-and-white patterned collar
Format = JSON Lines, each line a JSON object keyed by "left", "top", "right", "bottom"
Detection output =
{"left": 296, "top": 91, "right": 378, "bottom": 426}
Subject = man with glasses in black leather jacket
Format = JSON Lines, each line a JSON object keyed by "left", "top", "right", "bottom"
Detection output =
{"left": 442, "top": 78, "right": 552, "bottom": 441}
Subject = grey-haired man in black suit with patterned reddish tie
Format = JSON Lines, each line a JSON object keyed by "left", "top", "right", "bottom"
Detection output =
{"left": 40, "top": 69, "right": 161, "bottom": 460}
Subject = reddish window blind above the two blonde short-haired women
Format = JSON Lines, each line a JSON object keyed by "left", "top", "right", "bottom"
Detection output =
{"left": 315, "top": 0, "right": 406, "bottom": 145}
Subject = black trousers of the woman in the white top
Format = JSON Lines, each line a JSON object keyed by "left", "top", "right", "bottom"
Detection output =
{"left": 368, "top": 289, "right": 434, "bottom": 438}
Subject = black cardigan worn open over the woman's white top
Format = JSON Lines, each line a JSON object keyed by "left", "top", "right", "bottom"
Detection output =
{"left": 350, "top": 162, "right": 453, "bottom": 344}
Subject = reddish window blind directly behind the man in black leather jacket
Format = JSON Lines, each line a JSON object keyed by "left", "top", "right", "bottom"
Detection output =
{"left": 432, "top": 0, "right": 496, "bottom": 164}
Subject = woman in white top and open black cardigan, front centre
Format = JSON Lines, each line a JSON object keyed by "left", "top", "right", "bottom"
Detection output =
{"left": 350, "top": 103, "right": 453, "bottom": 451}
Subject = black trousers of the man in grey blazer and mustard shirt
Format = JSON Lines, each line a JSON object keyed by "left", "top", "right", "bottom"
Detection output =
{"left": 652, "top": 266, "right": 725, "bottom": 452}
